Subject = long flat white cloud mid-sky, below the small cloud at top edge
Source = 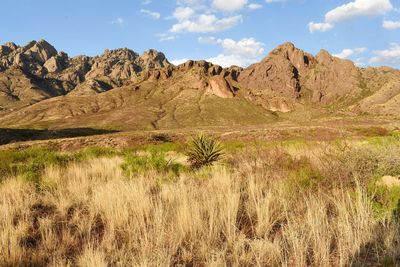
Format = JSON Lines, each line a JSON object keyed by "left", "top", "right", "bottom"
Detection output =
{"left": 170, "top": 14, "right": 243, "bottom": 33}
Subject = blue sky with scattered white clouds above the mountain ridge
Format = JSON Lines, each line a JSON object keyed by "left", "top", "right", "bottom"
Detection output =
{"left": 0, "top": 0, "right": 400, "bottom": 68}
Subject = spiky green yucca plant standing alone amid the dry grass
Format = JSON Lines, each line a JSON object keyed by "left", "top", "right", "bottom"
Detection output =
{"left": 186, "top": 134, "right": 224, "bottom": 169}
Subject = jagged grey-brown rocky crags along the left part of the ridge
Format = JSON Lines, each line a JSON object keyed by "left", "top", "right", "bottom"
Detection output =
{"left": 0, "top": 40, "right": 172, "bottom": 101}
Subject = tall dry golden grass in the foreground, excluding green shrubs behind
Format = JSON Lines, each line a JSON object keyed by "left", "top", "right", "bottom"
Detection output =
{"left": 0, "top": 141, "right": 400, "bottom": 266}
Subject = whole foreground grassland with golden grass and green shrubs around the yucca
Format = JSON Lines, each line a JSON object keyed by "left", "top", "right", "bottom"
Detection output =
{"left": 0, "top": 133, "right": 400, "bottom": 266}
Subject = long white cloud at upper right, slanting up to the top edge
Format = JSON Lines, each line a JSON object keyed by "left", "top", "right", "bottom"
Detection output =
{"left": 309, "top": 0, "right": 394, "bottom": 32}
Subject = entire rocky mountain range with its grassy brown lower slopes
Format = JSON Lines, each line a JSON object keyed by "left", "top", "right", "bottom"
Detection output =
{"left": 0, "top": 40, "right": 400, "bottom": 129}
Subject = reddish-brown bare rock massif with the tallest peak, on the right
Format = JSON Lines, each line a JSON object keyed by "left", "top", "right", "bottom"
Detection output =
{"left": 239, "top": 43, "right": 378, "bottom": 112}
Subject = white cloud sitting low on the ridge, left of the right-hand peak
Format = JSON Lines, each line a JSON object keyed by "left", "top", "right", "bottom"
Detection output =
{"left": 198, "top": 37, "right": 264, "bottom": 67}
